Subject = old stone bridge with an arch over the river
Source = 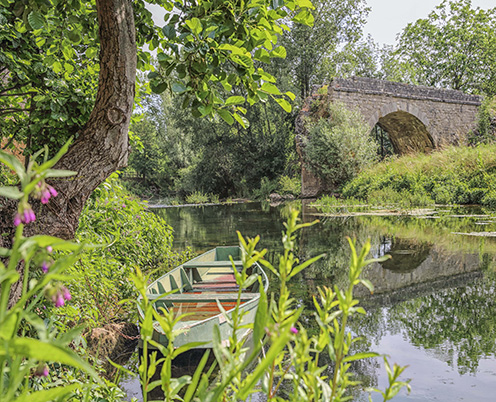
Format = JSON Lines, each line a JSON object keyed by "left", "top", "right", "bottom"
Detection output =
{"left": 296, "top": 77, "right": 481, "bottom": 197}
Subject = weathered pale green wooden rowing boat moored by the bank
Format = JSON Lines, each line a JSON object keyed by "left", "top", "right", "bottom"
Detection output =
{"left": 140, "top": 246, "right": 269, "bottom": 348}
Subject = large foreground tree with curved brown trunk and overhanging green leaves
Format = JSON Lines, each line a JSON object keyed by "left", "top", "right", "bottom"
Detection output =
{"left": 0, "top": 0, "right": 313, "bottom": 237}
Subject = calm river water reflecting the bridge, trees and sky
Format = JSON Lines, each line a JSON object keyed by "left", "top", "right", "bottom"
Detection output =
{"left": 155, "top": 203, "right": 496, "bottom": 401}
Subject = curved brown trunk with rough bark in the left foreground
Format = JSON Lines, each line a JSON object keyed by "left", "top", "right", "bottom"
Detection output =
{"left": 0, "top": 0, "right": 137, "bottom": 300}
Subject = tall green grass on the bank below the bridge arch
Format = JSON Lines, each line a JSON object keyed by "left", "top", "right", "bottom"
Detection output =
{"left": 342, "top": 144, "right": 496, "bottom": 207}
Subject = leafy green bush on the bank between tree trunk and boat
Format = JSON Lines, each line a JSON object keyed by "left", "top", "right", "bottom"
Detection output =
{"left": 58, "top": 175, "right": 189, "bottom": 327}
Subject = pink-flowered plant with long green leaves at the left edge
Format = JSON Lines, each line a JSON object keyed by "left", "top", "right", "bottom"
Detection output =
{"left": 0, "top": 143, "right": 99, "bottom": 402}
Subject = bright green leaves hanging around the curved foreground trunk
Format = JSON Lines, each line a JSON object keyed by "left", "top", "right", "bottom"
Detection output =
{"left": 0, "top": 0, "right": 313, "bottom": 153}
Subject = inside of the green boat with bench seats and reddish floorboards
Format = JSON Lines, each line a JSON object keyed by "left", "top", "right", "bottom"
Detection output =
{"left": 148, "top": 247, "right": 260, "bottom": 321}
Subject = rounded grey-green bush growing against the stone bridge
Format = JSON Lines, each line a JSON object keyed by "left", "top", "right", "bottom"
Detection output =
{"left": 305, "top": 103, "right": 377, "bottom": 187}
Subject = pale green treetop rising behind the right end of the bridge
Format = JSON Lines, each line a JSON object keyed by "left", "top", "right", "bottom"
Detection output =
{"left": 396, "top": 0, "right": 496, "bottom": 95}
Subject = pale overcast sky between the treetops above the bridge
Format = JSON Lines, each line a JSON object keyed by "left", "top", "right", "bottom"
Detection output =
{"left": 364, "top": 0, "right": 496, "bottom": 45}
